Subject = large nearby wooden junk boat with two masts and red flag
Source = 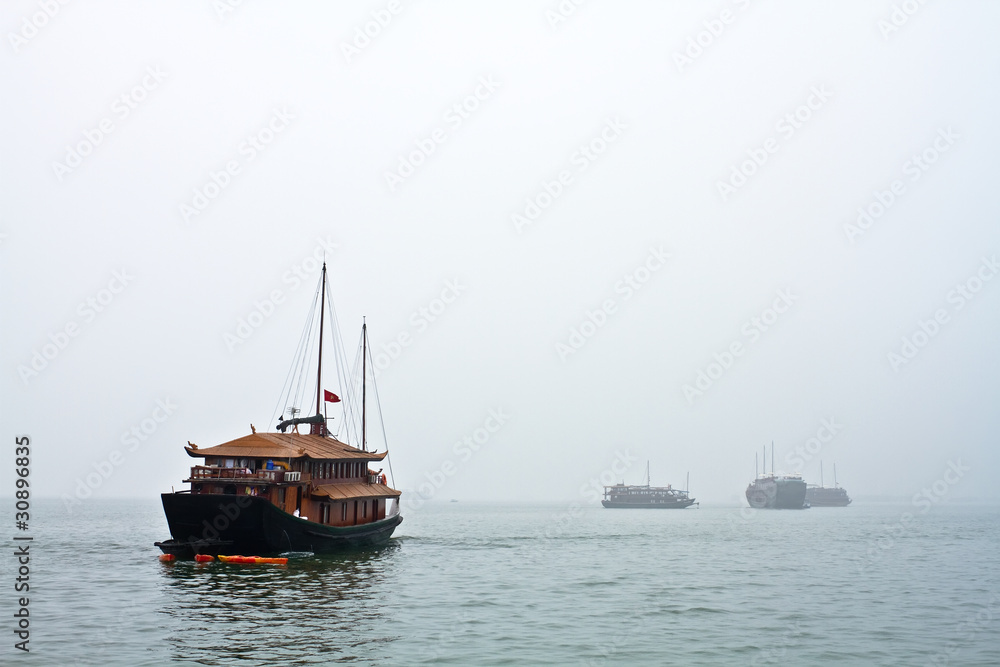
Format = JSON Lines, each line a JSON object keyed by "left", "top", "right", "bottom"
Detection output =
{"left": 155, "top": 263, "right": 403, "bottom": 558}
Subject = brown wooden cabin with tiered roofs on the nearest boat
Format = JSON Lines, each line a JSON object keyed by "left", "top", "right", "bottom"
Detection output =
{"left": 184, "top": 431, "right": 400, "bottom": 526}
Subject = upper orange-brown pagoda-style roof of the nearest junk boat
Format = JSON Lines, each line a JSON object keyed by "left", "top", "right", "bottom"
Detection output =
{"left": 184, "top": 433, "right": 388, "bottom": 461}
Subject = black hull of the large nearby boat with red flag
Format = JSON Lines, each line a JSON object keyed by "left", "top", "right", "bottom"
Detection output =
{"left": 156, "top": 493, "right": 403, "bottom": 558}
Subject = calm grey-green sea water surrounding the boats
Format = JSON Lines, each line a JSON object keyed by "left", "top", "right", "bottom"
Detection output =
{"left": 0, "top": 499, "right": 1000, "bottom": 665}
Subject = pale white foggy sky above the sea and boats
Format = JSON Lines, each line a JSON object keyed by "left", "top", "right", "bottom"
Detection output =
{"left": 0, "top": 0, "right": 1000, "bottom": 504}
